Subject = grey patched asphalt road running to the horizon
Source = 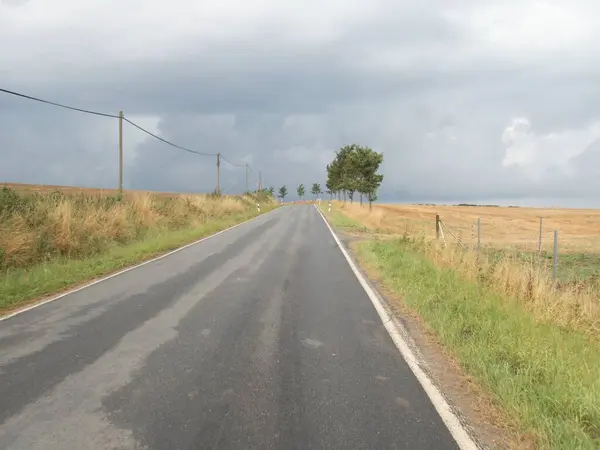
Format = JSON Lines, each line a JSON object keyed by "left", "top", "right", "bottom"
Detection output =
{"left": 0, "top": 205, "right": 457, "bottom": 450}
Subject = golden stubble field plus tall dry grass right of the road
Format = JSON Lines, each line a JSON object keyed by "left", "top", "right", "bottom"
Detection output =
{"left": 335, "top": 203, "right": 600, "bottom": 336}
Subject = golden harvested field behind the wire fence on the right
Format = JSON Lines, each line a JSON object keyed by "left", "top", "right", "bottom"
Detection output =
{"left": 340, "top": 204, "right": 600, "bottom": 282}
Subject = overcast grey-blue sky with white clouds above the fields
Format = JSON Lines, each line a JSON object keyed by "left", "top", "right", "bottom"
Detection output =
{"left": 0, "top": 0, "right": 600, "bottom": 206}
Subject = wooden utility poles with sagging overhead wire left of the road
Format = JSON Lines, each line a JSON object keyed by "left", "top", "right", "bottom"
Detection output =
{"left": 0, "top": 88, "right": 254, "bottom": 193}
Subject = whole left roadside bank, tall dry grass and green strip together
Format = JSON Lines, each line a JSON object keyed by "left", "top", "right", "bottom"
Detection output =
{"left": 0, "top": 184, "right": 275, "bottom": 314}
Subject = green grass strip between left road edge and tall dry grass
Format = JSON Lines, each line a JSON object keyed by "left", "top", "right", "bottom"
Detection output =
{"left": 0, "top": 207, "right": 273, "bottom": 315}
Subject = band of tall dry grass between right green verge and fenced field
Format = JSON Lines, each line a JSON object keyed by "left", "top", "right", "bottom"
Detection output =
{"left": 330, "top": 204, "right": 600, "bottom": 336}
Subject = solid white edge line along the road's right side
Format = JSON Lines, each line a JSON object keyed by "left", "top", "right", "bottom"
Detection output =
{"left": 315, "top": 205, "right": 480, "bottom": 450}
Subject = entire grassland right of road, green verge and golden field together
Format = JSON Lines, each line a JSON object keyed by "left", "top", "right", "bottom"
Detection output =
{"left": 322, "top": 202, "right": 600, "bottom": 449}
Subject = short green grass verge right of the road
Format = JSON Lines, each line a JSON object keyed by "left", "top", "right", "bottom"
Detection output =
{"left": 356, "top": 237, "right": 600, "bottom": 449}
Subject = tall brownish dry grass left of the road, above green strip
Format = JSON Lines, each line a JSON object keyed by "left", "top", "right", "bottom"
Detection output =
{"left": 0, "top": 188, "right": 265, "bottom": 270}
